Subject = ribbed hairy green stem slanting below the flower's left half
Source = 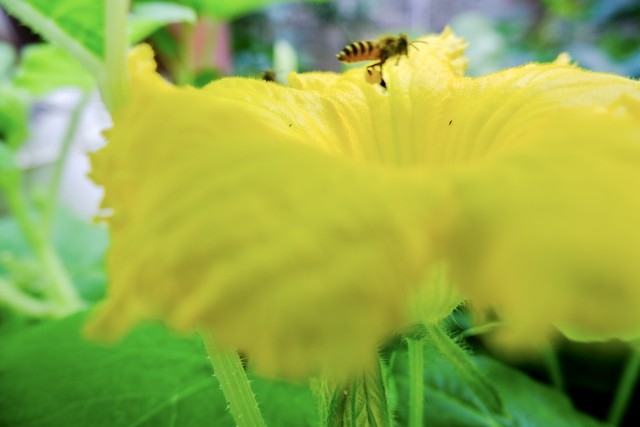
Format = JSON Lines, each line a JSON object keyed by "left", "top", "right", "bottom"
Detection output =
{"left": 201, "top": 332, "right": 265, "bottom": 427}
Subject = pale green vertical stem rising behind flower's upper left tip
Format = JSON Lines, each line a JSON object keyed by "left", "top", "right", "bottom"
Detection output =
{"left": 104, "top": 0, "right": 130, "bottom": 113}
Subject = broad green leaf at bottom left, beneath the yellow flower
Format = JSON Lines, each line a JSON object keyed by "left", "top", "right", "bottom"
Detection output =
{"left": 0, "top": 314, "right": 318, "bottom": 427}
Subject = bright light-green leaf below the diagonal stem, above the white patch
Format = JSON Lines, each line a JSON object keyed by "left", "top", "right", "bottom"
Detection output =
{"left": 14, "top": 43, "right": 95, "bottom": 96}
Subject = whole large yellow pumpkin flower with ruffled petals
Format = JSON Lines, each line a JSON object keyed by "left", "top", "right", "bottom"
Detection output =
{"left": 89, "top": 29, "right": 640, "bottom": 377}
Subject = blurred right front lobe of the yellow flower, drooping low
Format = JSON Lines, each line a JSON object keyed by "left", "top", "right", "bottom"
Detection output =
{"left": 443, "top": 99, "right": 640, "bottom": 346}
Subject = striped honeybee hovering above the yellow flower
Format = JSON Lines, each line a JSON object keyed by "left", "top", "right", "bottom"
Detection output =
{"left": 336, "top": 33, "right": 426, "bottom": 88}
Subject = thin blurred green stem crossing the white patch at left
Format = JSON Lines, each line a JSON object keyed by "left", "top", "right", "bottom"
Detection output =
{"left": 42, "top": 92, "right": 89, "bottom": 235}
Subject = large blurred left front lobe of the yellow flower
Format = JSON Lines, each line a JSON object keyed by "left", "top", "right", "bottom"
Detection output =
{"left": 89, "top": 42, "right": 447, "bottom": 377}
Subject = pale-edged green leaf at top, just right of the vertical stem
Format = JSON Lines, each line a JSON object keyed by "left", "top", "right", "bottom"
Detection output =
{"left": 129, "top": 2, "right": 198, "bottom": 44}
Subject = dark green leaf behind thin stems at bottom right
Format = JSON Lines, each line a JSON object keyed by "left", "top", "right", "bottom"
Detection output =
{"left": 392, "top": 341, "right": 604, "bottom": 427}
